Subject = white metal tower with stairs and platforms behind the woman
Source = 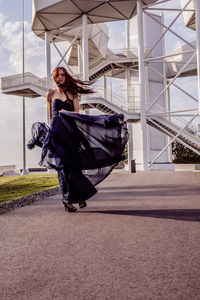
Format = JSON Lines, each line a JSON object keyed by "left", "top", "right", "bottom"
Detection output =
{"left": 2, "top": 0, "right": 200, "bottom": 170}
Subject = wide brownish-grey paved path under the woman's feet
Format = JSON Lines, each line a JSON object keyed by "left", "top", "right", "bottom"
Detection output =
{"left": 0, "top": 172, "right": 200, "bottom": 300}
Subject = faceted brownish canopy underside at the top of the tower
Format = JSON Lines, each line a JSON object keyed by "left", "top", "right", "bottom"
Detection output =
{"left": 32, "top": 0, "right": 158, "bottom": 38}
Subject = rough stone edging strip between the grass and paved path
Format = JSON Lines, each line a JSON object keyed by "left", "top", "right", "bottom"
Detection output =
{"left": 0, "top": 187, "right": 60, "bottom": 214}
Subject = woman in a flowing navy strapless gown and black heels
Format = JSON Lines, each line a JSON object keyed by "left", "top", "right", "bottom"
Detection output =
{"left": 27, "top": 67, "right": 128, "bottom": 212}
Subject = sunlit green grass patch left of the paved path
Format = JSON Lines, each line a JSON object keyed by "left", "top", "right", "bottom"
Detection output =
{"left": 0, "top": 174, "right": 59, "bottom": 204}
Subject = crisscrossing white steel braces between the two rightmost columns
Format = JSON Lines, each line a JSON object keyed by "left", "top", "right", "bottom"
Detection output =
{"left": 138, "top": 0, "right": 200, "bottom": 169}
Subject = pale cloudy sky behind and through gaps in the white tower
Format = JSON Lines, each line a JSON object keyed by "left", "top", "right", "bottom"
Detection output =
{"left": 0, "top": 0, "right": 197, "bottom": 167}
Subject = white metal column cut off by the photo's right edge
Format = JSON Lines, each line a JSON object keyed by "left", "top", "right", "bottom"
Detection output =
{"left": 195, "top": 0, "right": 200, "bottom": 114}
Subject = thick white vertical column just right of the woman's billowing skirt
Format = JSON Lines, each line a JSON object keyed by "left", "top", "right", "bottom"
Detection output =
{"left": 137, "top": 0, "right": 148, "bottom": 170}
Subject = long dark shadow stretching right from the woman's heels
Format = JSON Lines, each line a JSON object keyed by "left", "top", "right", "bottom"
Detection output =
{"left": 82, "top": 209, "right": 200, "bottom": 222}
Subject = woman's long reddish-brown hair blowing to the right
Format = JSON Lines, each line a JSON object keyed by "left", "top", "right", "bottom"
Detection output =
{"left": 53, "top": 67, "right": 94, "bottom": 96}
